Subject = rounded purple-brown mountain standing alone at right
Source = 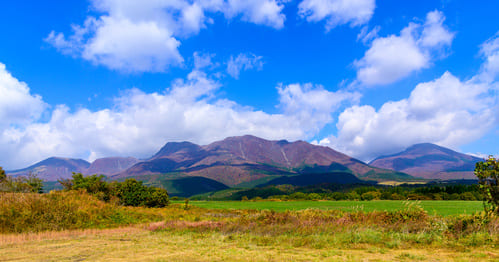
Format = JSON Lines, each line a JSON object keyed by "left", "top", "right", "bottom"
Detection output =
{"left": 369, "top": 143, "right": 482, "bottom": 180}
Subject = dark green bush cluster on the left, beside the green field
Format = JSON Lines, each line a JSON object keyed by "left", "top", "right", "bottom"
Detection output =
{"left": 59, "top": 173, "right": 169, "bottom": 207}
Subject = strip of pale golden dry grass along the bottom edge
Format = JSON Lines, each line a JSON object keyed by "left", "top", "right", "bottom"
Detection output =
{"left": 0, "top": 224, "right": 499, "bottom": 261}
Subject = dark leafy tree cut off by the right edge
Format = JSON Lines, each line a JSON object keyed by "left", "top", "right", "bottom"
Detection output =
{"left": 475, "top": 156, "right": 499, "bottom": 214}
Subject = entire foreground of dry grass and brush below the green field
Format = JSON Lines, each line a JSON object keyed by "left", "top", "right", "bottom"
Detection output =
{"left": 0, "top": 192, "right": 499, "bottom": 261}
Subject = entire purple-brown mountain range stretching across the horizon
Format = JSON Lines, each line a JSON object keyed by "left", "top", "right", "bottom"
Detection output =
{"left": 7, "top": 135, "right": 481, "bottom": 195}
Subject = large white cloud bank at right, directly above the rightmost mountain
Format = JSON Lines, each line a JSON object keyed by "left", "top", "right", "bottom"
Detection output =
{"left": 320, "top": 72, "right": 498, "bottom": 160}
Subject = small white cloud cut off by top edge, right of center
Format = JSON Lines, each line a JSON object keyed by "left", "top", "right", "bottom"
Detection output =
{"left": 298, "top": 0, "right": 376, "bottom": 31}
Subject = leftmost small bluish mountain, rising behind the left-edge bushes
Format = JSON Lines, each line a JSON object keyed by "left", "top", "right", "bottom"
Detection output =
{"left": 7, "top": 157, "right": 90, "bottom": 181}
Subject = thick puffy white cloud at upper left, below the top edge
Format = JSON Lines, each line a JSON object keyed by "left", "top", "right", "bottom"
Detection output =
{"left": 82, "top": 17, "right": 183, "bottom": 72}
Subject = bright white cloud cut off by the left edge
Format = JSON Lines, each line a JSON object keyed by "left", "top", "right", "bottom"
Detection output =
{"left": 0, "top": 63, "right": 47, "bottom": 130}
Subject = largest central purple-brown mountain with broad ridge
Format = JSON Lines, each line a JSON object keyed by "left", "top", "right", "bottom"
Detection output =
{"left": 117, "top": 135, "right": 411, "bottom": 186}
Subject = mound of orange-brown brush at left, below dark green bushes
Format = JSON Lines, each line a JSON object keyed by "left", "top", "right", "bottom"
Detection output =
{"left": 0, "top": 190, "right": 168, "bottom": 234}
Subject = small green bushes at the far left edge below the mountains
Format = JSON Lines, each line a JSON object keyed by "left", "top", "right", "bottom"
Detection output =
{"left": 0, "top": 167, "right": 43, "bottom": 193}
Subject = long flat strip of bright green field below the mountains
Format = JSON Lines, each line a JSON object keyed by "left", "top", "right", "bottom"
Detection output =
{"left": 182, "top": 200, "right": 483, "bottom": 216}
